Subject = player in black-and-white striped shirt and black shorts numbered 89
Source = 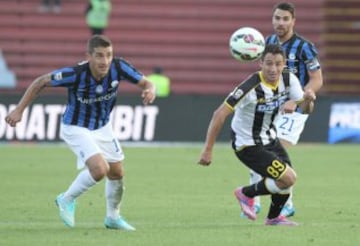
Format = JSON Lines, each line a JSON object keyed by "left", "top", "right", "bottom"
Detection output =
{"left": 198, "top": 44, "right": 316, "bottom": 226}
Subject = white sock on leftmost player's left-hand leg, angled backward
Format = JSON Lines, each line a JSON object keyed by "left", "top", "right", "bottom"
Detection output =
{"left": 64, "top": 168, "right": 96, "bottom": 201}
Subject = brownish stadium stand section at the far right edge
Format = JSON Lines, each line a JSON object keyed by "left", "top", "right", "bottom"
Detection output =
{"left": 322, "top": 0, "right": 360, "bottom": 95}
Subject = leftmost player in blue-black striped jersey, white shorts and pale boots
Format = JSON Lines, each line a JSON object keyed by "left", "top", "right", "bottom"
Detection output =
{"left": 5, "top": 35, "right": 155, "bottom": 230}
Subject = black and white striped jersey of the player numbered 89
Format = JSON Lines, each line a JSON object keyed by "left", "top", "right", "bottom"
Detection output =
{"left": 224, "top": 72, "right": 304, "bottom": 149}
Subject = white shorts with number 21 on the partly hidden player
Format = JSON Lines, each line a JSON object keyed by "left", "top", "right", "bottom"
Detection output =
{"left": 275, "top": 112, "right": 309, "bottom": 145}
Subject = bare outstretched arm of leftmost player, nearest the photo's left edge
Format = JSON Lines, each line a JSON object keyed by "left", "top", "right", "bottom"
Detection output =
{"left": 5, "top": 73, "right": 51, "bottom": 127}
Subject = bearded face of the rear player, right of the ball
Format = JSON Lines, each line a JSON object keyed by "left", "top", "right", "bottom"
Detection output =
{"left": 272, "top": 9, "right": 295, "bottom": 41}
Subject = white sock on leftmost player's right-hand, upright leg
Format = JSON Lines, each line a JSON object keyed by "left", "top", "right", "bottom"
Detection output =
{"left": 105, "top": 178, "right": 124, "bottom": 219}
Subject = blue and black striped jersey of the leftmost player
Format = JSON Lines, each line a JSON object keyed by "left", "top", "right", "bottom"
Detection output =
{"left": 51, "top": 58, "right": 143, "bottom": 130}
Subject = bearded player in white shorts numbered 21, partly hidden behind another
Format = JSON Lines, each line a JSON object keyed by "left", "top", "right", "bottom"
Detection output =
{"left": 250, "top": 2, "right": 323, "bottom": 217}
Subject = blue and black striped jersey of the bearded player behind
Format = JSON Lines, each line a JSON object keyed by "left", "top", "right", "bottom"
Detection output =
{"left": 266, "top": 33, "right": 320, "bottom": 87}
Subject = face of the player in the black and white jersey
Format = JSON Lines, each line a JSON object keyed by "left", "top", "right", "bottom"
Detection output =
{"left": 260, "top": 53, "right": 285, "bottom": 85}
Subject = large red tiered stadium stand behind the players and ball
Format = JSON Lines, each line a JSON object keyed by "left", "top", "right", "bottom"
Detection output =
{"left": 0, "top": 0, "right": 330, "bottom": 94}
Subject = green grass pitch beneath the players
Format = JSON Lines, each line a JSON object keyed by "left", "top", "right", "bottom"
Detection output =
{"left": 0, "top": 144, "right": 360, "bottom": 246}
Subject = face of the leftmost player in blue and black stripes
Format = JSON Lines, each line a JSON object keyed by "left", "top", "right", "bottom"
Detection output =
{"left": 88, "top": 46, "right": 113, "bottom": 79}
